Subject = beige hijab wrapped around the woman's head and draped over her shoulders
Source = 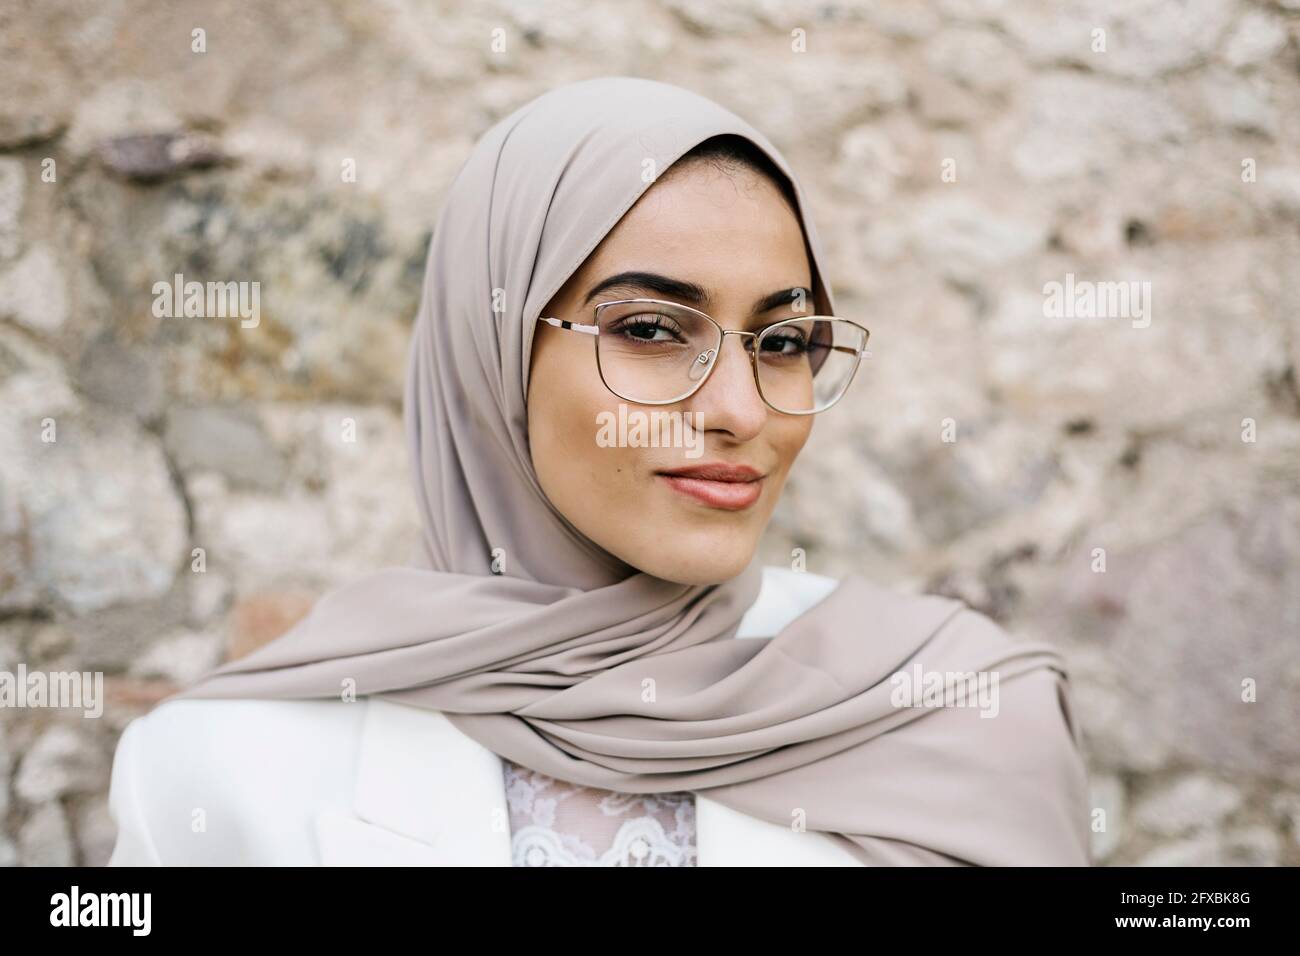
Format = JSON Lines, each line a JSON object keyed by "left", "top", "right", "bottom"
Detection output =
{"left": 167, "top": 77, "right": 1088, "bottom": 865}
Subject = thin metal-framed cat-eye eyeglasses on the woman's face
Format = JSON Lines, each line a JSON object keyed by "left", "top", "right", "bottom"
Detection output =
{"left": 540, "top": 299, "right": 870, "bottom": 415}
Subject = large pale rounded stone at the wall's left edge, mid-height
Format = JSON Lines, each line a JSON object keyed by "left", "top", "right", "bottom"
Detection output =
{"left": 0, "top": 328, "right": 186, "bottom": 615}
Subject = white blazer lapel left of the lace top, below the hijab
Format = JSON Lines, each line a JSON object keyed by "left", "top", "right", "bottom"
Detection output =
{"left": 316, "top": 697, "right": 511, "bottom": 866}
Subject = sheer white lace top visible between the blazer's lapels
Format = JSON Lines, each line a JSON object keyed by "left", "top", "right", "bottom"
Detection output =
{"left": 502, "top": 760, "right": 696, "bottom": 866}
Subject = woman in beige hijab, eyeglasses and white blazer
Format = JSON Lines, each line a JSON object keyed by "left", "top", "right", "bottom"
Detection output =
{"left": 111, "top": 78, "right": 1087, "bottom": 865}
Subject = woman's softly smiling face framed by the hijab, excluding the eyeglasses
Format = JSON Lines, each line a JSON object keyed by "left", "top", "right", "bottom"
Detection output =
{"left": 528, "top": 163, "right": 813, "bottom": 584}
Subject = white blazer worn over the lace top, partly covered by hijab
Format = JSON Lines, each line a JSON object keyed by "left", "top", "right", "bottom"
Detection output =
{"left": 109, "top": 567, "right": 859, "bottom": 866}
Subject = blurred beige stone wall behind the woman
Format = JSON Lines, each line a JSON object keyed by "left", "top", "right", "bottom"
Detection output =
{"left": 0, "top": 0, "right": 1300, "bottom": 865}
